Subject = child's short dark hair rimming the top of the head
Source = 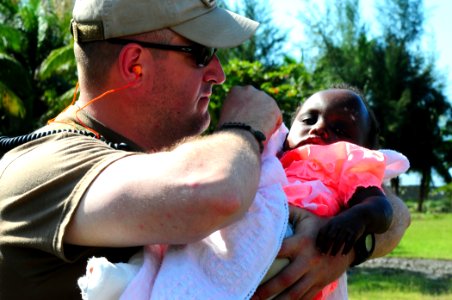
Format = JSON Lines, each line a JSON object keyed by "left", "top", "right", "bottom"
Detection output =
{"left": 291, "top": 82, "right": 380, "bottom": 149}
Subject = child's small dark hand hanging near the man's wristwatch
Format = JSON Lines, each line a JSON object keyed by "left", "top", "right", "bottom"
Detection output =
{"left": 316, "top": 213, "right": 366, "bottom": 256}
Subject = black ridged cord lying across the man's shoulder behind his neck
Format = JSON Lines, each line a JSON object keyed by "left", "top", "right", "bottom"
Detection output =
{"left": 0, "top": 129, "right": 130, "bottom": 157}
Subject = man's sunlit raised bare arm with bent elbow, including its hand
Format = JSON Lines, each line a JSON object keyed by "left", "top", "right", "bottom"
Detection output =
{"left": 64, "top": 87, "right": 281, "bottom": 247}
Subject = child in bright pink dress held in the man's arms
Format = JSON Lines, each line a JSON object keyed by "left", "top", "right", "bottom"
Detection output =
{"left": 264, "top": 85, "right": 409, "bottom": 299}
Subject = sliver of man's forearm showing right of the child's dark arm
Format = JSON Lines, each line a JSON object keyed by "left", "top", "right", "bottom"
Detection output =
{"left": 372, "top": 187, "right": 411, "bottom": 258}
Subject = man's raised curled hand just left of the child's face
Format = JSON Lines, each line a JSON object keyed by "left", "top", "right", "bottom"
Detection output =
{"left": 218, "top": 86, "right": 282, "bottom": 141}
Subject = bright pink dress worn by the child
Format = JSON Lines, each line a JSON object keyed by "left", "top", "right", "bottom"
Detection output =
{"left": 281, "top": 142, "right": 409, "bottom": 299}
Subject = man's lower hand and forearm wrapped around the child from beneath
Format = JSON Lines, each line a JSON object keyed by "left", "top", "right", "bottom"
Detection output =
{"left": 253, "top": 189, "right": 410, "bottom": 299}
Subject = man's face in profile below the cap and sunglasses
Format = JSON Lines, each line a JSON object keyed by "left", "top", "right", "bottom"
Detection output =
{"left": 136, "top": 35, "right": 225, "bottom": 146}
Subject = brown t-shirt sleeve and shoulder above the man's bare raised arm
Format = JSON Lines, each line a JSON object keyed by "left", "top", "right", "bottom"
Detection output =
{"left": 0, "top": 133, "right": 136, "bottom": 260}
